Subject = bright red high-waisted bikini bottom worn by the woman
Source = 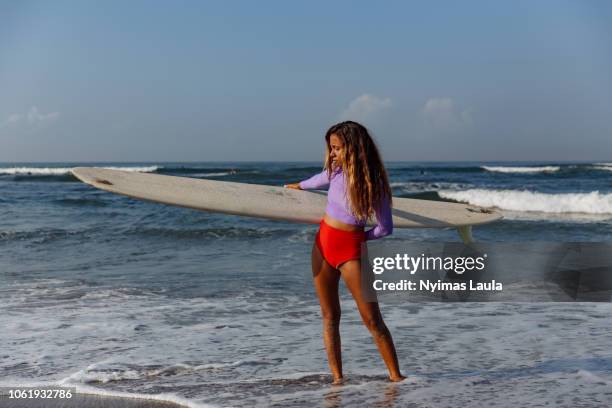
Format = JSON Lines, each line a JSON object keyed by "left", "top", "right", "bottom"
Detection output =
{"left": 315, "top": 220, "right": 365, "bottom": 269}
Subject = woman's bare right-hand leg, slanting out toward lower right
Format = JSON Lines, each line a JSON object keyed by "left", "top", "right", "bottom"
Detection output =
{"left": 340, "top": 260, "right": 406, "bottom": 381}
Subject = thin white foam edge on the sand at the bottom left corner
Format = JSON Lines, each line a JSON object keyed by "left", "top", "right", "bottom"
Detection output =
{"left": 0, "top": 379, "right": 214, "bottom": 408}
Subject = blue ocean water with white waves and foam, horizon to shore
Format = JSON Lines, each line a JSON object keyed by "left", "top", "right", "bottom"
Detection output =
{"left": 0, "top": 162, "right": 612, "bottom": 407}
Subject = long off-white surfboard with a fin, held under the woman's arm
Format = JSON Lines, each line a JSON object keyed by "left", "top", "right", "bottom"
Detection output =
{"left": 72, "top": 167, "right": 502, "bottom": 241}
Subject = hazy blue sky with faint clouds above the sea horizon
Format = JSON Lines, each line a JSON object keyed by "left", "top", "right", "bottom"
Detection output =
{"left": 0, "top": 0, "right": 612, "bottom": 162}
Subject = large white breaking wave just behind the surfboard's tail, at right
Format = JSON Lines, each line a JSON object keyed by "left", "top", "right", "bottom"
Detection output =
{"left": 439, "top": 189, "right": 612, "bottom": 214}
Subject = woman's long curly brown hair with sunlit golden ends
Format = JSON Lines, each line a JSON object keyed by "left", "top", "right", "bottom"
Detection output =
{"left": 325, "top": 121, "right": 392, "bottom": 222}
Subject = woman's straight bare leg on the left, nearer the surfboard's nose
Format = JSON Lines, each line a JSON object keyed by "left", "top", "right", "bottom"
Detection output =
{"left": 312, "top": 244, "right": 342, "bottom": 384}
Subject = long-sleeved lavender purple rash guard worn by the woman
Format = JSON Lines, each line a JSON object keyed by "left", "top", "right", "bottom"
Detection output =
{"left": 300, "top": 169, "right": 393, "bottom": 240}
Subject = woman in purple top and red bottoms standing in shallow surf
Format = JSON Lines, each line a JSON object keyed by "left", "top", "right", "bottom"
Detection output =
{"left": 285, "top": 121, "right": 405, "bottom": 384}
